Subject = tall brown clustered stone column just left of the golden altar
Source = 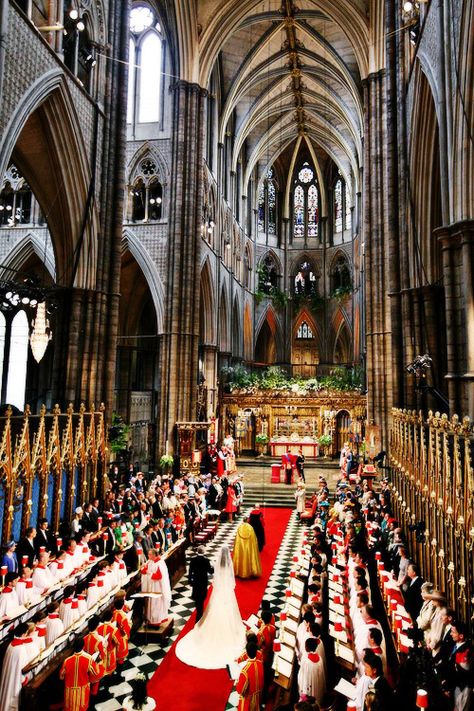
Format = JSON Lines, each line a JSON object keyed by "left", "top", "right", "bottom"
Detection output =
{"left": 157, "top": 81, "right": 206, "bottom": 455}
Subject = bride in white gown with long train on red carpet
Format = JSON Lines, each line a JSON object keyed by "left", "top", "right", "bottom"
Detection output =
{"left": 176, "top": 546, "right": 245, "bottom": 669}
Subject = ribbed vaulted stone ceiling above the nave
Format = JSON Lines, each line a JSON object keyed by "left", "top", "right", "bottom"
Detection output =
{"left": 194, "top": 0, "right": 369, "bottom": 192}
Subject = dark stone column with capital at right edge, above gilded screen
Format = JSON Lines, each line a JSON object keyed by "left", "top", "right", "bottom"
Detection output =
{"left": 435, "top": 220, "right": 474, "bottom": 417}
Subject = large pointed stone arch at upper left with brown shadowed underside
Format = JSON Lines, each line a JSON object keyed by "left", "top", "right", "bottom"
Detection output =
{"left": 0, "top": 76, "right": 98, "bottom": 288}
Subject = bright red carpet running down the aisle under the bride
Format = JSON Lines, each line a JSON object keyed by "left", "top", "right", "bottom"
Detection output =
{"left": 148, "top": 509, "right": 291, "bottom": 711}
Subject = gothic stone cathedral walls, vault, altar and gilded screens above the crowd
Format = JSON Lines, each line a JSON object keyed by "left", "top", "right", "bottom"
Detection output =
{"left": 0, "top": 0, "right": 474, "bottom": 708}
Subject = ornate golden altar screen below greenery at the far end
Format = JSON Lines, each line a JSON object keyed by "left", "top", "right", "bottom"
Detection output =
{"left": 221, "top": 389, "right": 367, "bottom": 459}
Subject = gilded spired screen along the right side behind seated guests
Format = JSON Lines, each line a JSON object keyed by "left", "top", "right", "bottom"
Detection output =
{"left": 390, "top": 409, "right": 474, "bottom": 625}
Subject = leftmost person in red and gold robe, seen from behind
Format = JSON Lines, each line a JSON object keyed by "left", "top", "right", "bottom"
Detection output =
{"left": 59, "top": 639, "right": 104, "bottom": 711}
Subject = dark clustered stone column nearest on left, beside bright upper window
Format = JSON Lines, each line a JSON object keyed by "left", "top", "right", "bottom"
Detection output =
{"left": 52, "top": 2, "right": 129, "bottom": 416}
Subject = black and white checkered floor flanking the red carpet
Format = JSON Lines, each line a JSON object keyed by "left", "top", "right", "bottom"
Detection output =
{"left": 94, "top": 512, "right": 304, "bottom": 711}
